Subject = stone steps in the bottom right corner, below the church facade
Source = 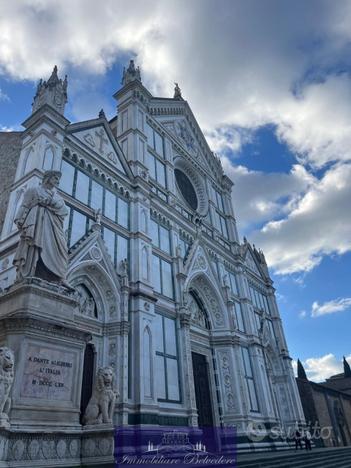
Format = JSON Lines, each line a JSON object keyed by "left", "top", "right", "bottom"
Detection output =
{"left": 237, "top": 447, "right": 351, "bottom": 468}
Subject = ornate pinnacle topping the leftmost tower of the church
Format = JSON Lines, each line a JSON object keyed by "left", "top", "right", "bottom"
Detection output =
{"left": 32, "top": 65, "right": 67, "bottom": 114}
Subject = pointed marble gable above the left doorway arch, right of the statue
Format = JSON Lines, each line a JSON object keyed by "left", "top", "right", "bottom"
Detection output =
{"left": 69, "top": 230, "right": 120, "bottom": 284}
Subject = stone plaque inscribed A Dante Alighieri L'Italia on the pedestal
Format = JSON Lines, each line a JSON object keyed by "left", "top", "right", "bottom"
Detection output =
{"left": 21, "top": 345, "right": 77, "bottom": 401}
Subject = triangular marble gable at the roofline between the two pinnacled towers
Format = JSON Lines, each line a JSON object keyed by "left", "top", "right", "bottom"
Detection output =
{"left": 67, "top": 117, "right": 133, "bottom": 178}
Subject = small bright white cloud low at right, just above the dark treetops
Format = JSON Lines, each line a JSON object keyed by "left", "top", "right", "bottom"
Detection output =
{"left": 293, "top": 353, "right": 351, "bottom": 382}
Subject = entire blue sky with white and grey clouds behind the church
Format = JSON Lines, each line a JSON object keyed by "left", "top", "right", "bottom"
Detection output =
{"left": 0, "top": 0, "right": 351, "bottom": 380}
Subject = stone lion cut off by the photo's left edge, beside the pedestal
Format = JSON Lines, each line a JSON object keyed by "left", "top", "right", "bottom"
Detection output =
{"left": 0, "top": 347, "right": 15, "bottom": 426}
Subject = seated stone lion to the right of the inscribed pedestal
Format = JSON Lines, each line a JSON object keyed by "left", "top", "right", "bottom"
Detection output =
{"left": 83, "top": 367, "right": 118, "bottom": 425}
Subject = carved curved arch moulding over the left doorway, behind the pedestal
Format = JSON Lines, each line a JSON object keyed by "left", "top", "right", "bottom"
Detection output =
{"left": 67, "top": 261, "right": 121, "bottom": 323}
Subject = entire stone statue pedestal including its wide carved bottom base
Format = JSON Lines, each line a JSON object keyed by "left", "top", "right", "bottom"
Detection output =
{"left": 0, "top": 279, "right": 114, "bottom": 468}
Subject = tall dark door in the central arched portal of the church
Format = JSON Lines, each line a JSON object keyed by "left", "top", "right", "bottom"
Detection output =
{"left": 191, "top": 353, "right": 213, "bottom": 427}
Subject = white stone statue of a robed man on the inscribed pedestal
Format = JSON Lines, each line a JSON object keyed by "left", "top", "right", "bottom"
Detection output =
{"left": 13, "top": 171, "right": 68, "bottom": 283}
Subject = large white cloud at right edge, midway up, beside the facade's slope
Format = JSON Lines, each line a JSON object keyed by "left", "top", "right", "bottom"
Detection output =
{"left": 252, "top": 164, "right": 351, "bottom": 274}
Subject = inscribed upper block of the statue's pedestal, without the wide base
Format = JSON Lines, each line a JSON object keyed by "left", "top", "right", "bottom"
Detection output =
{"left": 0, "top": 280, "right": 89, "bottom": 429}
